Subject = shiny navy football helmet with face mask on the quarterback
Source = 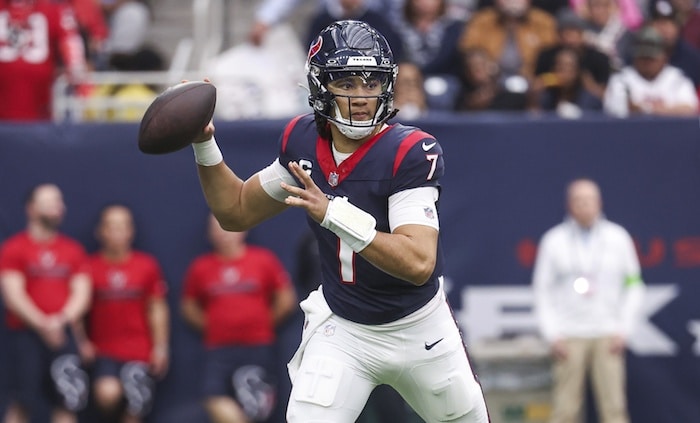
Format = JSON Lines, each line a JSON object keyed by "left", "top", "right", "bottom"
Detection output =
{"left": 306, "top": 20, "right": 398, "bottom": 139}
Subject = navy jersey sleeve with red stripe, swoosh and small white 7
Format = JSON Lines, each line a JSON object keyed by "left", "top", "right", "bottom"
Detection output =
{"left": 392, "top": 131, "right": 445, "bottom": 194}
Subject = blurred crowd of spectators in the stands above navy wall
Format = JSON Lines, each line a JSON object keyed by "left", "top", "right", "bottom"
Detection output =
{"left": 0, "top": 0, "right": 700, "bottom": 120}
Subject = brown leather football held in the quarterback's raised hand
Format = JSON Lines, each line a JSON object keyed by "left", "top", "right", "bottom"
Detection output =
{"left": 138, "top": 81, "right": 216, "bottom": 154}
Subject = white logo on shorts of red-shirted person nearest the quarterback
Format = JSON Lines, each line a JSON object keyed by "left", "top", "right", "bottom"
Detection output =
{"left": 231, "top": 365, "right": 276, "bottom": 421}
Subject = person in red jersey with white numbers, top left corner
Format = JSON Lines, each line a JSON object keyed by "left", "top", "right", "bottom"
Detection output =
{"left": 0, "top": 0, "right": 86, "bottom": 121}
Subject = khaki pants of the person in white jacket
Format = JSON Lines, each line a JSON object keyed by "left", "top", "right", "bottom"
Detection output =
{"left": 550, "top": 338, "right": 629, "bottom": 423}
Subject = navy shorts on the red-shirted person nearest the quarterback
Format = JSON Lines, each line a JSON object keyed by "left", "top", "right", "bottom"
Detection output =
{"left": 203, "top": 346, "right": 276, "bottom": 421}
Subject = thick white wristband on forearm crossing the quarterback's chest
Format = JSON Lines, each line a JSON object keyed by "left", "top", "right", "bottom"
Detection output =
{"left": 321, "top": 197, "right": 377, "bottom": 253}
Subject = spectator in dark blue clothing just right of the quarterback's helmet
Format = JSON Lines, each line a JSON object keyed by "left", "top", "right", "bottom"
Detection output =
{"left": 396, "top": 0, "right": 465, "bottom": 77}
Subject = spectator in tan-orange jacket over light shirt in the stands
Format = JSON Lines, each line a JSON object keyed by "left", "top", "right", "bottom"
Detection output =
{"left": 460, "top": 0, "right": 557, "bottom": 85}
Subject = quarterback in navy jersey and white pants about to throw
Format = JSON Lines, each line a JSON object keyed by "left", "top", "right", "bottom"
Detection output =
{"left": 193, "top": 21, "right": 489, "bottom": 423}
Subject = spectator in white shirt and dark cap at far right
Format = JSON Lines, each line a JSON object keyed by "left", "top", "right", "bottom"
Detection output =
{"left": 603, "top": 27, "right": 698, "bottom": 117}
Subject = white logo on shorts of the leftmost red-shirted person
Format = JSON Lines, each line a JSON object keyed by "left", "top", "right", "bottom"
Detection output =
{"left": 50, "top": 354, "right": 88, "bottom": 411}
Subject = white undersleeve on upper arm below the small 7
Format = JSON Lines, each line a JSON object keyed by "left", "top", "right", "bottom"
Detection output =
{"left": 389, "top": 187, "right": 440, "bottom": 232}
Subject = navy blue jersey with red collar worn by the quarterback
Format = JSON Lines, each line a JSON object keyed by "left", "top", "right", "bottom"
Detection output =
{"left": 279, "top": 114, "right": 444, "bottom": 324}
